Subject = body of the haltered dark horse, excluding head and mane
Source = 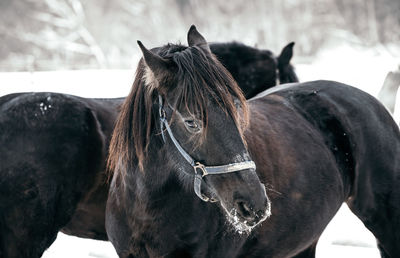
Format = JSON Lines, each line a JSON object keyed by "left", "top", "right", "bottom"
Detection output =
{"left": 109, "top": 81, "right": 400, "bottom": 257}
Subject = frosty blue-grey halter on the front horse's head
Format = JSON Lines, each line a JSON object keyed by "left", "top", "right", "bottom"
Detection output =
{"left": 158, "top": 95, "right": 256, "bottom": 202}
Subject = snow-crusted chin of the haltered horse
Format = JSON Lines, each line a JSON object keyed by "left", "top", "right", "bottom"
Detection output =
{"left": 221, "top": 203, "right": 271, "bottom": 235}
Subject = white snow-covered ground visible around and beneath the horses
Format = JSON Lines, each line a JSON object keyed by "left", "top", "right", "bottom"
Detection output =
{"left": 0, "top": 43, "right": 398, "bottom": 258}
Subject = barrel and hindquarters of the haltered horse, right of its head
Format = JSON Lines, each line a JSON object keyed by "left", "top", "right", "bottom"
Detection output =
{"left": 238, "top": 81, "right": 400, "bottom": 257}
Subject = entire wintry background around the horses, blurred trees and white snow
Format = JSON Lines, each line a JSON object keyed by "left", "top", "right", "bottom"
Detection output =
{"left": 0, "top": 0, "right": 400, "bottom": 258}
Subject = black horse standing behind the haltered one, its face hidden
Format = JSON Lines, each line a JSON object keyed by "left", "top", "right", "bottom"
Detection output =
{"left": 0, "top": 40, "right": 297, "bottom": 257}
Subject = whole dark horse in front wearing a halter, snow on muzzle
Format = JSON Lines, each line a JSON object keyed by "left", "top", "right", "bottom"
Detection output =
{"left": 106, "top": 27, "right": 400, "bottom": 257}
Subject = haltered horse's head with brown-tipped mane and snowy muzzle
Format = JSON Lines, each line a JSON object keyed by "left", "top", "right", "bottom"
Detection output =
{"left": 111, "top": 26, "right": 270, "bottom": 232}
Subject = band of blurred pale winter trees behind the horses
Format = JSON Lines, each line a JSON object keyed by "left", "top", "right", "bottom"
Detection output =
{"left": 0, "top": 0, "right": 400, "bottom": 71}
